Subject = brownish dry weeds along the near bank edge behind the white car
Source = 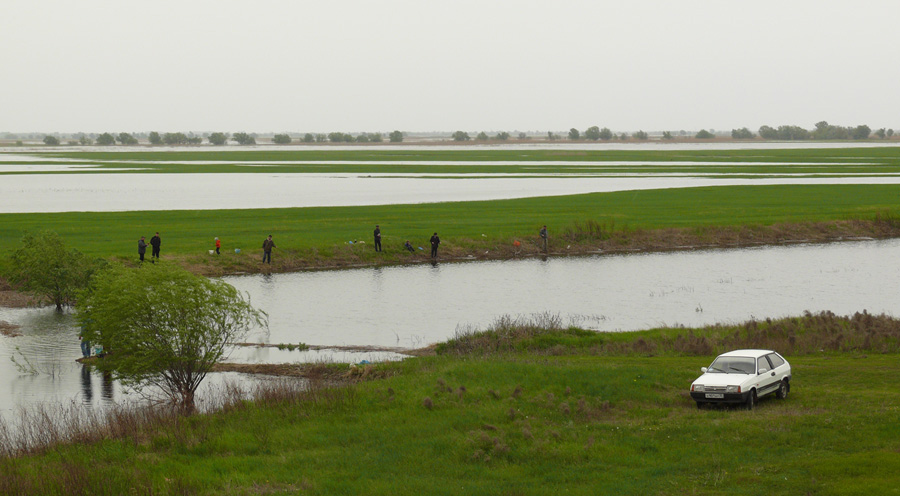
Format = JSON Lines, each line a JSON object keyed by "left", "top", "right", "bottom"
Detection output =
{"left": 435, "top": 311, "right": 900, "bottom": 356}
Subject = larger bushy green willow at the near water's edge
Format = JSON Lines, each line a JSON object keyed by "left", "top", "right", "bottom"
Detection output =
{"left": 76, "top": 263, "right": 266, "bottom": 413}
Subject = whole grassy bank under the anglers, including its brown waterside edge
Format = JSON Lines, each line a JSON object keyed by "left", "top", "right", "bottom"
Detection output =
{"left": 0, "top": 185, "right": 900, "bottom": 280}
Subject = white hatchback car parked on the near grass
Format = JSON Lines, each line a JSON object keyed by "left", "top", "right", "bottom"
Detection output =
{"left": 691, "top": 350, "right": 791, "bottom": 410}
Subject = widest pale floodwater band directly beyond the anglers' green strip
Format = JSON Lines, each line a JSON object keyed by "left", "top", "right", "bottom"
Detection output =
{"left": 0, "top": 173, "right": 900, "bottom": 213}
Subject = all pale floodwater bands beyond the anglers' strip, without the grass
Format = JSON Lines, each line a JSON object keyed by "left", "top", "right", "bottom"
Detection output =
{"left": 0, "top": 142, "right": 900, "bottom": 213}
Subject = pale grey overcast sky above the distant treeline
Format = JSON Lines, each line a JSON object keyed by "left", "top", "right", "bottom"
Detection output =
{"left": 0, "top": 0, "right": 900, "bottom": 132}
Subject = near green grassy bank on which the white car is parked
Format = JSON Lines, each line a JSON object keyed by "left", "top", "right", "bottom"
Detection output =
{"left": 0, "top": 315, "right": 900, "bottom": 495}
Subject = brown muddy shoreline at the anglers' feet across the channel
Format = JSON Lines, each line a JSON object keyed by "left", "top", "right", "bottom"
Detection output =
{"left": 0, "top": 218, "right": 900, "bottom": 308}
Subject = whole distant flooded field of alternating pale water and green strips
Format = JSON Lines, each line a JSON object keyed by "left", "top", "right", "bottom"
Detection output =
{"left": 0, "top": 142, "right": 900, "bottom": 213}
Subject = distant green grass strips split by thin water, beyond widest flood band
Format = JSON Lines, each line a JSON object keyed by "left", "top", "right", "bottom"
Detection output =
{"left": 12, "top": 147, "right": 900, "bottom": 177}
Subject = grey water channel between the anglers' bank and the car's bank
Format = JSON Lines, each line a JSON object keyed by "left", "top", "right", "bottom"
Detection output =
{"left": 0, "top": 240, "right": 900, "bottom": 424}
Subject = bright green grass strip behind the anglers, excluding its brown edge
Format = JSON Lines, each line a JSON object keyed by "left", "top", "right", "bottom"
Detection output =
{"left": 0, "top": 185, "right": 900, "bottom": 263}
